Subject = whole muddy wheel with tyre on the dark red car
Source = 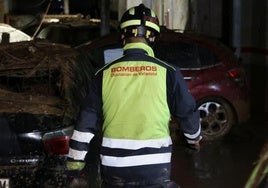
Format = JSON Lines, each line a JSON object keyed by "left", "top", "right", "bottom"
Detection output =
{"left": 197, "top": 98, "right": 235, "bottom": 140}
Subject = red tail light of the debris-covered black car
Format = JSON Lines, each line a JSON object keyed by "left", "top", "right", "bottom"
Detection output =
{"left": 43, "top": 127, "right": 73, "bottom": 155}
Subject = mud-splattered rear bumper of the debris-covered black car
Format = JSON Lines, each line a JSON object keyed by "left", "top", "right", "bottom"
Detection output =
{"left": 0, "top": 156, "right": 66, "bottom": 187}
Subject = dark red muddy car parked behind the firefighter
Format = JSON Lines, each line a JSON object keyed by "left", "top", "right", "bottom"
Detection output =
{"left": 79, "top": 28, "right": 250, "bottom": 140}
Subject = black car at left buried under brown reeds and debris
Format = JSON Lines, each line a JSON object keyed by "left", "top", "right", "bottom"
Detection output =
{"left": 0, "top": 40, "right": 93, "bottom": 187}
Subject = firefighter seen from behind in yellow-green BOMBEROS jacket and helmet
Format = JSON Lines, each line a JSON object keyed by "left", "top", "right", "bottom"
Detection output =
{"left": 67, "top": 4, "right": 202, "bottom": 188}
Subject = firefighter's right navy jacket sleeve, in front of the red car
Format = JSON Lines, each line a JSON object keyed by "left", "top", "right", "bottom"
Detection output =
{"left": 168, "top": 68, "right": 202, "bottom": 144}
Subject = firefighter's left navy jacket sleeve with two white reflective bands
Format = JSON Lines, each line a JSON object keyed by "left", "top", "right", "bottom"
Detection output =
{"left": 68, "top": 76, "right": 102, "bottom": 161}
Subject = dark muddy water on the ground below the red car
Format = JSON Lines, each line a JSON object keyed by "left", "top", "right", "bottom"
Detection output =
{"left": 172, "top": 120, "right": 268, "bottom": 188}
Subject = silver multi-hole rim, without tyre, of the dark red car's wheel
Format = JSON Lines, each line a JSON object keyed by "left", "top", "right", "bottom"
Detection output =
{"left": 198, "top": 102, "right": 228, "bottom": 137}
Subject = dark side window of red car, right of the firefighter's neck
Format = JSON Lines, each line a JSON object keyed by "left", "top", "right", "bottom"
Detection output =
{"left": 154, "top": 41, "right": 219, "bottom": 68}
